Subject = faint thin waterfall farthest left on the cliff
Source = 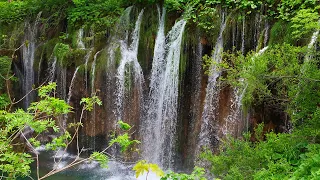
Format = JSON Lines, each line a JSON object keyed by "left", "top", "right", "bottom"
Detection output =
{"left": 22, "top": 12, "right": 41, "bottom": 109}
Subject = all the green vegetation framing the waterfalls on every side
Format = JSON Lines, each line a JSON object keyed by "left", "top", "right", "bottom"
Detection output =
{"left": 0, "top": 0, "right": 320, "bottom": 179}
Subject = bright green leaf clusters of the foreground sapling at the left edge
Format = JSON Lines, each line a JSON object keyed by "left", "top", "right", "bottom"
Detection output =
{"left": 0, "top": 83, "right": 70, "bottom": 179}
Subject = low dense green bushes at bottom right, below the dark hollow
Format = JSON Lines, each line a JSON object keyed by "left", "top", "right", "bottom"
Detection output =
{"left": 201, "top": 133, "right": 307, "bottom": 179}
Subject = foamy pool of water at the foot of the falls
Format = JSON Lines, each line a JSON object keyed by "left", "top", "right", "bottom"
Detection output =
{"left": 22, "top": 148, "right": 160, "bottom": 180}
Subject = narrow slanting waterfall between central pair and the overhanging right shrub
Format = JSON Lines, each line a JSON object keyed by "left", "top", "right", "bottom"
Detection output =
{"left": 196, "top": 13, "right": 227, "bottom": 154}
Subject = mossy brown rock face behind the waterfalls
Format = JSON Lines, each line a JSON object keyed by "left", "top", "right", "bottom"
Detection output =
{"left": 9, "top": 7, "right": 288, "bottom": 168}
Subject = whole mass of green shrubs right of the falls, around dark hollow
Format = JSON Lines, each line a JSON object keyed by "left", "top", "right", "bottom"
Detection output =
{"left": 202, "top": 41, "right": 320, "bottom": 179}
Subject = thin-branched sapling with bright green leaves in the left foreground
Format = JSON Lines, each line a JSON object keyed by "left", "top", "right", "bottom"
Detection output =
{"left": 0, "top": 83, "right": 140, "bottom": 179}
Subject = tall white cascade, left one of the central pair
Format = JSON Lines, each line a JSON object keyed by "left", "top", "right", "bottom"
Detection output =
{"left": 142, "top": 6, "right": 166, "bottom": 166}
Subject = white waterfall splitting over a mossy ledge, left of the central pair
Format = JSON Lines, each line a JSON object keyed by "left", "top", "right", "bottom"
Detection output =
{"left": 116, "top": 10, "right": 144, "bottom": 120}
